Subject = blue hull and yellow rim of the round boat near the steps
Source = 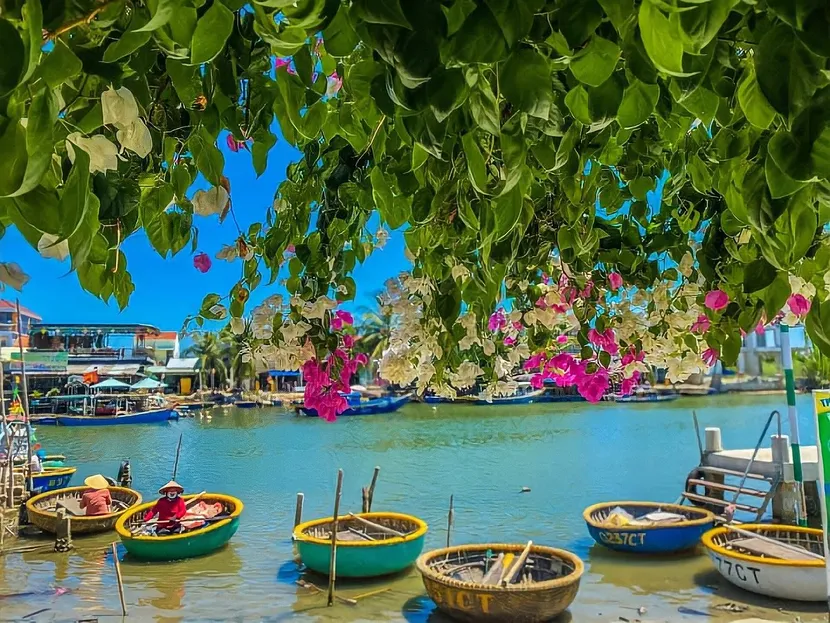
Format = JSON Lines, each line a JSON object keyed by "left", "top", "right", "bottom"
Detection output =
{"left": 584, "top": 502, "right": 715, "bottom": 554}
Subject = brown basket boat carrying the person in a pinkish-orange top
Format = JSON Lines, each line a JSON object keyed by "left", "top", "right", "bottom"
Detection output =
{"left": 26, "top": 487, "right": 141, "bottom": 534}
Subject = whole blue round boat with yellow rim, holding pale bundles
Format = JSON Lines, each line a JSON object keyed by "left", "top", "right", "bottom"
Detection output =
{"left": 582, "top": 502, "right": 715, "bottom": 554}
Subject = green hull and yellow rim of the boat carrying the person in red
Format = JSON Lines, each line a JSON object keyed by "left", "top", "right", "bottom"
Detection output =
{"left": 115, "top": 493, "right": 244, "bottom": 561}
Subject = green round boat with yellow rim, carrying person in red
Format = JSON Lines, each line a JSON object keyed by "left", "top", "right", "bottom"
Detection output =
{"left": 115, "top": 493, "right": 244, "bottom": 561}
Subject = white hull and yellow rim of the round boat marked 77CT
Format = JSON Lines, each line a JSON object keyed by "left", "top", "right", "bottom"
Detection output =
{"left": 703, "top": 525, "right": 827, "bottom": 602}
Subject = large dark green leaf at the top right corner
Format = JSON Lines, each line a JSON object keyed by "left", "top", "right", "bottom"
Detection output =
{"left": 755, "top": 24, "right": 823, "bottom": 119}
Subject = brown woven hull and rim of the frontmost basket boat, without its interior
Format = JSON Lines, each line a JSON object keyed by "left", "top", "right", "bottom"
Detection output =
{"left": 417, "top": 544, "right": 584, "bottom": 623}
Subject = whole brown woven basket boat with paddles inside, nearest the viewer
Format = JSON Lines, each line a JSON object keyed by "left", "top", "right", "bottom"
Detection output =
{"left": 416, "top": 544, "right": 585, "bottom": 623}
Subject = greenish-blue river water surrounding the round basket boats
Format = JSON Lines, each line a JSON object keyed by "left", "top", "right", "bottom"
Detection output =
{"left": 0, "top": 394, "right": 826, "bottom": 623}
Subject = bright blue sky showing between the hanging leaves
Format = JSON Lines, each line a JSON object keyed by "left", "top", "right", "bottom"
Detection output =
{"left": 0, "top": 132, "right": 409, "bottom": 331}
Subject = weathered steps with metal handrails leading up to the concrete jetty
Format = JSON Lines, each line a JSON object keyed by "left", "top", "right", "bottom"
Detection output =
{"left": 680, "top": 411, "right": 784, "bottom": 521}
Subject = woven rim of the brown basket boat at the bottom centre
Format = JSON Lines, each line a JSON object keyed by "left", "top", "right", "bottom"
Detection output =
{"left": 416, "top": 543, "right": 585, "bottom": 593}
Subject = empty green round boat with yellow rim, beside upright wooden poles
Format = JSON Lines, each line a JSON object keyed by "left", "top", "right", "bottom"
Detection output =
{"left": 293, "top": 513, "right": 427, "bottom": 578}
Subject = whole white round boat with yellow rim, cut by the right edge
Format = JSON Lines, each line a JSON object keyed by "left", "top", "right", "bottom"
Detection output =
{"left": 702, "top": 524, "right": 827, "bottom": 602}
